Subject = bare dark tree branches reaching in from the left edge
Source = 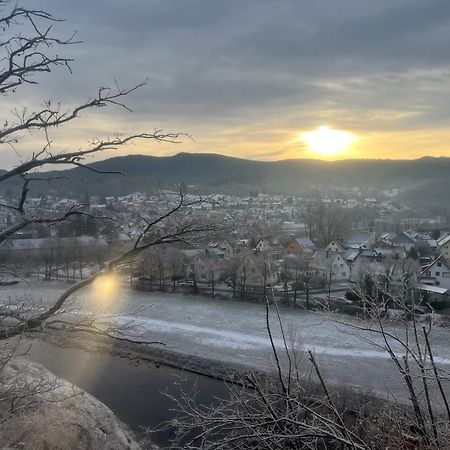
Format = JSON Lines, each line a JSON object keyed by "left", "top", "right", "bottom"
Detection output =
{"left": 0, "top": 1, "right": 199, "bottom": 339}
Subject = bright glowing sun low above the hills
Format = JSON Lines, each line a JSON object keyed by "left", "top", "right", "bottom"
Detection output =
{"left": 300, "top": 126, "right": 356, "bottom": 158}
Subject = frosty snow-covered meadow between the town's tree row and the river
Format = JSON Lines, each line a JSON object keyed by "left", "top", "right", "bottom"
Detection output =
{"left": 0, "top": 282, "right": 450, "bottom": 396}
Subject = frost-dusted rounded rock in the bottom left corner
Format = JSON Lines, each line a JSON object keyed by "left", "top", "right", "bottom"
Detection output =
{"left": 0, "top": 358, "right": 144, "bottom": 450}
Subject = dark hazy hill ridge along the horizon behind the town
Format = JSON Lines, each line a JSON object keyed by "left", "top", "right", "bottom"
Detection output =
{"left": 0, "top": 153, "right": 450, "bottom": 212}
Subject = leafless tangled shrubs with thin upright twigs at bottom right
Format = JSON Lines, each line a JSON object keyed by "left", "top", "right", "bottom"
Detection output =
{"left": 170, "top": 270, "right": 450, "bottom": 450}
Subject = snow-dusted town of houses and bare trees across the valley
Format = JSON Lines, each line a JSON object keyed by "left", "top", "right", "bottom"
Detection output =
{"left": 0, "top": 190, "right": 450, "bottom": 318}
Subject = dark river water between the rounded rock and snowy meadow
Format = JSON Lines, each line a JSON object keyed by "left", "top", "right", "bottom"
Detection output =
{"left": 29, "top": 341, "right": 229, "bottom": 446}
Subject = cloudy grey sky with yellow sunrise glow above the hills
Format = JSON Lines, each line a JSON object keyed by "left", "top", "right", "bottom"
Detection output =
{"left": 0, "top": 0, "right": 450, "bottom": 167}
